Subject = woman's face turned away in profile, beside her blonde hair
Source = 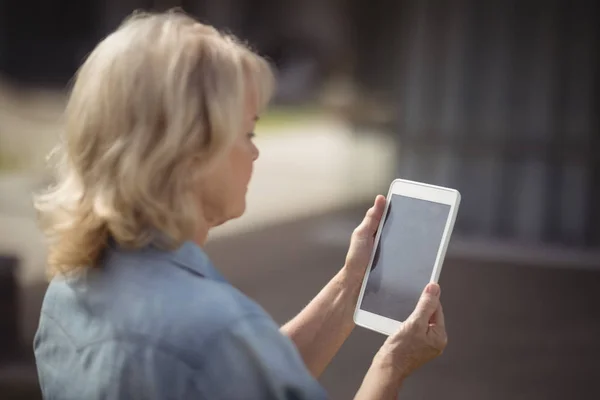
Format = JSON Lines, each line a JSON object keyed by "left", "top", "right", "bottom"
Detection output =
{"left": 200, "top": 84, "right": 259, "bottom": 227}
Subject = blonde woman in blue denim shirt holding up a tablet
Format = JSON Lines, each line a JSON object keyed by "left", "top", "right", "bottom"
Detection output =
{"left": 35, "top": 13, "right": 446, "bottom": 400}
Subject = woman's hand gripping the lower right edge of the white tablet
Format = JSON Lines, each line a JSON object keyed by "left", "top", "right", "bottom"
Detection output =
{"left": 373, "top": 283, "right": 448, "bottom": 380}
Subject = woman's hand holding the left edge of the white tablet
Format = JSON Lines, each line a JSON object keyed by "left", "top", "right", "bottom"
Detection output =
{"left": 344, "top": 195, "right": 385, "bottom": 288}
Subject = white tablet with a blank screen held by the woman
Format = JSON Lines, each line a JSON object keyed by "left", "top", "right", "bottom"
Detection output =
{"left": 354, "top": 179, "right": 460, "bottom": 335}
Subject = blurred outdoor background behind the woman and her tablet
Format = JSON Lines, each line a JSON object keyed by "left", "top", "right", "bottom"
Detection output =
{"left": 0, "top": 0, "right": 600, "bottom": 400}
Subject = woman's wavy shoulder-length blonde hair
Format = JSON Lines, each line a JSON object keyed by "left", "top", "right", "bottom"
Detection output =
{"left": 35, "top": 11, "right": 274, "bottom": 275}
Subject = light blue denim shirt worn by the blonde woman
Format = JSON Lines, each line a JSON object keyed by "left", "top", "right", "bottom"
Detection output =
{"left": 34, "top": 243, "right": 326, "bottom": 400}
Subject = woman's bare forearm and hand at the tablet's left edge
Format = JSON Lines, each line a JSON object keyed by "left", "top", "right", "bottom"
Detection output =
{"left": 281, "top": 196, "right": 385, "bottom": 377}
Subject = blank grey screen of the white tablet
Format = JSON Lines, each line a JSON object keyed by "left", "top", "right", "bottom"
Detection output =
{"left": 360, "top": 194, "right": 450, "bottom": 321}
